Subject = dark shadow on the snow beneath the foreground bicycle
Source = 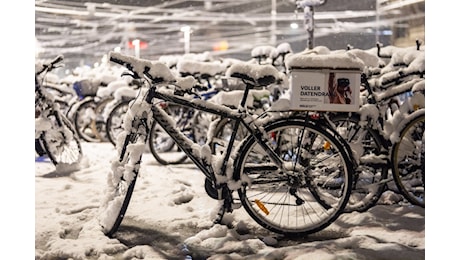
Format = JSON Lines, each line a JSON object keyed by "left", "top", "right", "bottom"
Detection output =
{"left": 115, "top": 217, "right": 349, "bottom": 260}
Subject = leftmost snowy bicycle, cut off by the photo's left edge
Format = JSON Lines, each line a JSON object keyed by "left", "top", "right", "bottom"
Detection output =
{"left": 35, "top": 56, "right": 83, "bottom": 166}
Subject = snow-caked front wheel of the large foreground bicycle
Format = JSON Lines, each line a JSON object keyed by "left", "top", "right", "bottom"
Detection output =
{"left": 98, "top": 132, "right": 145, "bottom": 237}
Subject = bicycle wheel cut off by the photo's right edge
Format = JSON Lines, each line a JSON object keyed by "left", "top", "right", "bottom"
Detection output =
{"left": 391, "top": 110, "right": 425, "bottom": 208}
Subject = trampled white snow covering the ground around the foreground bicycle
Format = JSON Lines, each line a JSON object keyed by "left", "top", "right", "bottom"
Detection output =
{"left": 35, "top": 142, "right": 425, "bottom": 260}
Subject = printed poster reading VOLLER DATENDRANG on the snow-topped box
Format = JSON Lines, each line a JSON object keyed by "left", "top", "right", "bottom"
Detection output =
{"left": 291, "top": 70, "right": 361, "bottom": 112}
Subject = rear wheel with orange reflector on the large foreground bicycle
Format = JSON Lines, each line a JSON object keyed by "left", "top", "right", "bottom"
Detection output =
{"left": 233, "top": 118, "right": 353, "bottom": 237}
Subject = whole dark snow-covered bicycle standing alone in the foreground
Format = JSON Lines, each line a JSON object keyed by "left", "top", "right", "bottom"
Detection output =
{"left": 98, "top": 52, "right": 353, "bottom": 237}
